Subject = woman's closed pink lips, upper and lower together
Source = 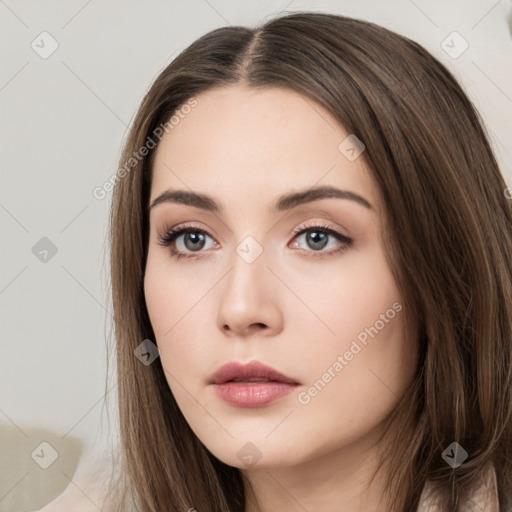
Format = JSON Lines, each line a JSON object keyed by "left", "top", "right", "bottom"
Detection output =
{"left": 210, "top": 361, "right": 300, "bottom": 408}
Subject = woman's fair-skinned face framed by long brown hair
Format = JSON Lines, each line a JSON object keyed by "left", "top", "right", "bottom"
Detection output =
{"left": 144, "top": 85, "right": 416, "bottom": 468}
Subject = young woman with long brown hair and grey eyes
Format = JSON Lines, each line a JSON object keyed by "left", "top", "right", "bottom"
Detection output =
{"left": 99, "top": 9, "right": 512, "bottom": 512}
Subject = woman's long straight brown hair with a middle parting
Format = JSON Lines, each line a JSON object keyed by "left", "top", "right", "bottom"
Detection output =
{"left": 104, "top": 12, "right": 512, "bottom": 512}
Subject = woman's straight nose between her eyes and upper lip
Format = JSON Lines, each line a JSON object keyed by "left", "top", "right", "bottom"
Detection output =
{"left": 218, "top": 245, "right": 283, "bottom": 338}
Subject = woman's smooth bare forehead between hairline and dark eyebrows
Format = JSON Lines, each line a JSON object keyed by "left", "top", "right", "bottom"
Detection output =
{"left": 151, "top": 85, "right": 377, "bottom": 213}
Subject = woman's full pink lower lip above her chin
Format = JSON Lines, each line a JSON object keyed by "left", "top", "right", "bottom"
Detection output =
{"left": 213, "top": 381, "right": 297, "bottom": 407}
